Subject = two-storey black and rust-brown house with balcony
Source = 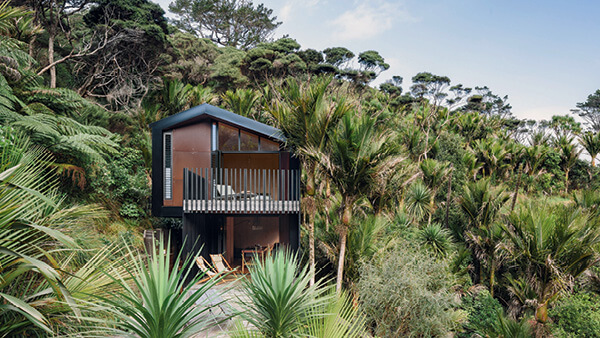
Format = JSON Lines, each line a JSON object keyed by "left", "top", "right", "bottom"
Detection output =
{"left": 150, "top": 104, "right": 300, "bottom": 262}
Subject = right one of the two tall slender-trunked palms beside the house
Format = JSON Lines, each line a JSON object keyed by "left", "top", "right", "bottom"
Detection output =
{"left": 312, "top": 111, "right": 403, "bottom": 292}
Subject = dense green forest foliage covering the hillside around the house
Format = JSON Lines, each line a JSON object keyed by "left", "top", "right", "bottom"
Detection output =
{"left": 0, "top": 0, "right": 600, "bottom": 337}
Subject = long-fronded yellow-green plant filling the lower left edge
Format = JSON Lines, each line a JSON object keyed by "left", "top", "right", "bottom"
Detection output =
{"left": 0, "top": 133, "right": 106, "bottom": 336}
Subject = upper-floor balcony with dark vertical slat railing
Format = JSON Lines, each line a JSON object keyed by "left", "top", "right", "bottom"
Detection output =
{"left": 183, "top": 168, "right": 300, "bottom": 214}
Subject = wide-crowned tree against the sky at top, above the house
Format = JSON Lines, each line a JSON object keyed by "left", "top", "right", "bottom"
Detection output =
{"left": 169, "top": 0, "right": 281, "bottom": 49}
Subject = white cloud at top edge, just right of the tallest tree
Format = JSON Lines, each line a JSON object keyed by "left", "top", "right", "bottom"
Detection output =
{"left": 330, "top": 1, "right": 416, "bottom": 40}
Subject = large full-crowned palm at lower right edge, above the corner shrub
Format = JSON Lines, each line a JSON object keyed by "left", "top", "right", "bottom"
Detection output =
{"left": 503, "top": 204, "right": 600, "bottom": 323}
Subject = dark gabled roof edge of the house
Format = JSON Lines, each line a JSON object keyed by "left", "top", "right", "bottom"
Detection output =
{"left": 150, "top": 103, "right": 286, "bottom": 142}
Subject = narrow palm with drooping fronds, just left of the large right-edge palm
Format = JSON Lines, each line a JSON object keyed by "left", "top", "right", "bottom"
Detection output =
{"left": 460, "top": 178, "right": 509, "bottom": 296}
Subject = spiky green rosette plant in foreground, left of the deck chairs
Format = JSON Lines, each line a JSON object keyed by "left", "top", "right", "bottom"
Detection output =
{"left": 92, "top": 238, "right": 229, "bottom": 338}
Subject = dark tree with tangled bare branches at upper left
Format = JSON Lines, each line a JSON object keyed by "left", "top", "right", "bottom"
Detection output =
{"left": 76, "top": 0, "right": 168, "bottom": 109}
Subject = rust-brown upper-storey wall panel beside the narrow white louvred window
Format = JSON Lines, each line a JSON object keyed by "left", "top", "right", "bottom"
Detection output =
{"left": 163, "top": 122, "right": 211, "bottom": 207}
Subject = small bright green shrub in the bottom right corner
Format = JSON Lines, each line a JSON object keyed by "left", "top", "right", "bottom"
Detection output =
{"left": 550, "top": 292, "right": 600, "bottom": 337}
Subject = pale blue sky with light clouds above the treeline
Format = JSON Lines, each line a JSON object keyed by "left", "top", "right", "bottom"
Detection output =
{"left": 158, "top": 0, "right": 600, "bottom": 120}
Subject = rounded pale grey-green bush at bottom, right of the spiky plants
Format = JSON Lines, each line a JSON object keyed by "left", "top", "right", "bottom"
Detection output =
{"left": 357, "top": 241, "right": 462, "bottom": 337}
